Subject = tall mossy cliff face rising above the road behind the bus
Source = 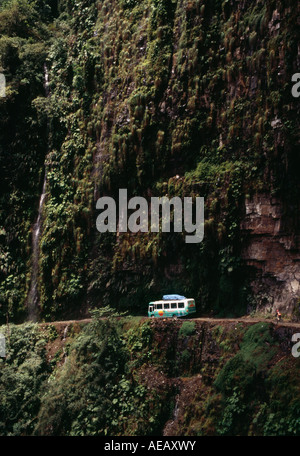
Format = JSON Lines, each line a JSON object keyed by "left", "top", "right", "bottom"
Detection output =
{"left": 0, "top": 0, "right": 299, "bottom": 319}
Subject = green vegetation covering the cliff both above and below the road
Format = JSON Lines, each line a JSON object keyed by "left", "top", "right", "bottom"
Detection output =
{"left": 0, "top": 0, "right": 300, "bottom": 436}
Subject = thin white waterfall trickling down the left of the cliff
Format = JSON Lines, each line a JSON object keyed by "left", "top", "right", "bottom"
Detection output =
{"left": 27, "top": 63, "right": 50, "bottom": 322}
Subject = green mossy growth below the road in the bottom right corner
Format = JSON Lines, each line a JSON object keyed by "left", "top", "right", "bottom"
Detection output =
{"left": 214, "top": 323, "right": 300, "bottom": 435}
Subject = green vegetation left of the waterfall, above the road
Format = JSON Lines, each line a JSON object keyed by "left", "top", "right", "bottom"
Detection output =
{"left": 0, "top": 0, "right": 52, "bottom": 319}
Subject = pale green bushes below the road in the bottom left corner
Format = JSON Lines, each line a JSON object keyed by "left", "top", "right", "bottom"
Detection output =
{"left": 0, "top": 324, "right": 50, "bottom": 435}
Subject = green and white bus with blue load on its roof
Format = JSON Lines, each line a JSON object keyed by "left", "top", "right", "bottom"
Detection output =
{"left": 148, "top": 298, "right": 196, "bottom": 318}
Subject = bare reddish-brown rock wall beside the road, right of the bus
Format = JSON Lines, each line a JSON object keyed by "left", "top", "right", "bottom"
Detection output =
{"left": 241, "top": 194, "right": 300, "bottom": 313}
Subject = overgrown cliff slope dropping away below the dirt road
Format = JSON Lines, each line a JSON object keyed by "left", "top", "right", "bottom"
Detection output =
{"left": 0, "top": 319, "right": 300, "bottom": 436}
